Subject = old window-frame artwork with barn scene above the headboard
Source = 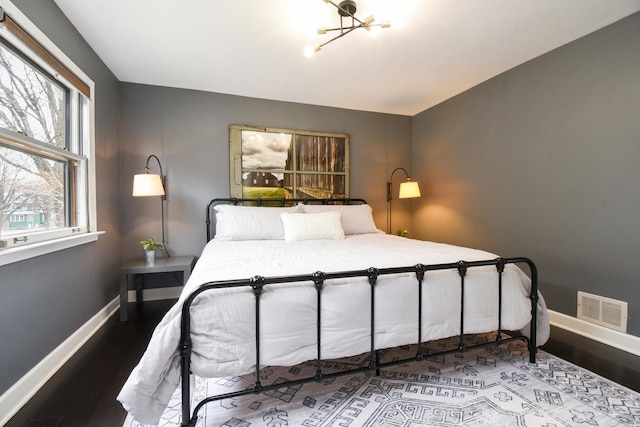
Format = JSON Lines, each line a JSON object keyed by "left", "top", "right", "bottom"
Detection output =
{"left": 229, "top": 125, "right": 349, "bottom": 199}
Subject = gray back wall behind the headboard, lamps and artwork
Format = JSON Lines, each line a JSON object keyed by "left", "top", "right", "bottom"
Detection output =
{"left": 121, "top": 83, "right": 411, "bottom": 259}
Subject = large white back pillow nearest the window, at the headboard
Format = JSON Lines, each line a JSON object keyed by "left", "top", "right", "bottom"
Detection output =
{"left": 214, "top": 205, "right": 302, "bottom": 240}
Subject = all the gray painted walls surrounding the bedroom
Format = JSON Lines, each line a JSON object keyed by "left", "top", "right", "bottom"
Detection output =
{"left": 0, "top": 0, "right": 640, "bottom": 404}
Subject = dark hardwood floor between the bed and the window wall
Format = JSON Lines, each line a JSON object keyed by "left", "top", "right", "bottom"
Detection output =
{"left": 5, "top": 300, "right": 175, "bottom": 427}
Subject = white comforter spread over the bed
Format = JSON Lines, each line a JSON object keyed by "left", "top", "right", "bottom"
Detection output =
{"left": 118, "top": 234, "right": 549, "bottom": 424}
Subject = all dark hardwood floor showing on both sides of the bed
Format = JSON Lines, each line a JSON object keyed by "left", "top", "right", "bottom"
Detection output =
{"left": 6, "top": 301, "right": 640, "bottom": 427}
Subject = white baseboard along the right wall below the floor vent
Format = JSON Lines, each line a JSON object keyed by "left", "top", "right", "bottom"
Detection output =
{"left": 549, "top": 310, "right": 640, "bottom": 356}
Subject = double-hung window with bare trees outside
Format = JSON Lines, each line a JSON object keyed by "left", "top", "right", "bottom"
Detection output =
{"left": 0, "top": 8, "right": 95, "bottom": 265}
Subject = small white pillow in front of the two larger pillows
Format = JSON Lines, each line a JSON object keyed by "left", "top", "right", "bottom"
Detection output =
{"left": 280, "top": 211, "right": 344, "bottom": 242}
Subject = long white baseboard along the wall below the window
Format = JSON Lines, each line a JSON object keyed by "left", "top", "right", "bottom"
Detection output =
{"left": 0, "top": 298, "right": 120, "bottom": 425}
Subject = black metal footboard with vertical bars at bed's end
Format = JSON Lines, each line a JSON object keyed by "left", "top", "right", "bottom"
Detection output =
{"left": 180, "top": 258, "right": 538, "bottom": 426}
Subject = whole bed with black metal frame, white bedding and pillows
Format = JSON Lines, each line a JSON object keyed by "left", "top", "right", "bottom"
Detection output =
{"left": 118, "top": 199, "right": 549, "bottom": 426}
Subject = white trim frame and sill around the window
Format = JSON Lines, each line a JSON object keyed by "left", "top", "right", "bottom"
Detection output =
{"left": 0, "top": 0, "right": 104, "bottom": 266}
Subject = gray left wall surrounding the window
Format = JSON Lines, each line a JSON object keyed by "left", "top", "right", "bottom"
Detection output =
{"left": 0, "top": 0, "right": 121, "bottom": 394}
